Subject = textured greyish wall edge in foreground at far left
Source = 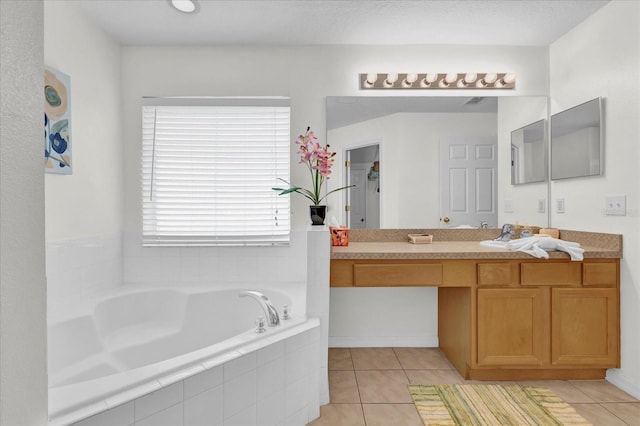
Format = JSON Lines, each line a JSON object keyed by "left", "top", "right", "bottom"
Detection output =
{"left": 0, "top": 0, "right": 47, "bottom": 426}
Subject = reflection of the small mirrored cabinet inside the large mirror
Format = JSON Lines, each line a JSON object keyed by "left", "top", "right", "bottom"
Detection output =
{"left": 511, "top": 120, "right": 547, "bottom": 185}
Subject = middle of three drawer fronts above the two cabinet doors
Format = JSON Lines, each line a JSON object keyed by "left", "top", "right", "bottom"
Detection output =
{"left": 520, "top": 262, "right": 582, "bottom": 286}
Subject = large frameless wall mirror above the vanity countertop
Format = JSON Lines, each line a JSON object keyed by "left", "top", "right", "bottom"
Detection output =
{"left": 326, "top": 96, "right": 548, "bottom": 229}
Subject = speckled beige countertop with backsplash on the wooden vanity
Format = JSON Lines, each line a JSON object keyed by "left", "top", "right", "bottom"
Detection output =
{"left": 331, "top": 229, "right": 622, "bottom": 259}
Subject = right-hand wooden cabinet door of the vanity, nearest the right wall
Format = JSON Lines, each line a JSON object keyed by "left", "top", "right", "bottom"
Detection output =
{"left": 551, "top": 288, "right": 619, "bottom": 367}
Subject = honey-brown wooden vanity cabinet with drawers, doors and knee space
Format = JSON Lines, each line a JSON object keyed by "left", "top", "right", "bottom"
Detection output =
{"left": 330, "top": 258, "right": 620, "bottom": 380}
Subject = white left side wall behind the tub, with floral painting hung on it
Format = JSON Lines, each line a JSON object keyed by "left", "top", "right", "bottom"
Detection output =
{"left": 44, "top": 1, "right": 123, "bottom": 303}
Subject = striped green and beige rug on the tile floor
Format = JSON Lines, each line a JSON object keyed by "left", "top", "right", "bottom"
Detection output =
{"left": 409, "top": 384, "right": 590, "bottom": 426}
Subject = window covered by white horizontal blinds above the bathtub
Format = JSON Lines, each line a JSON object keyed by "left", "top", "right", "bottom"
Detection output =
{"left": 142, "top": 98, "right": 290, "bottom": 246}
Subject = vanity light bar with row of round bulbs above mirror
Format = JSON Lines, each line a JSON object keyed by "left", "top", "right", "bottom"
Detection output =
{"left": 360, "top": 73, "right": 516, "bottom": 90}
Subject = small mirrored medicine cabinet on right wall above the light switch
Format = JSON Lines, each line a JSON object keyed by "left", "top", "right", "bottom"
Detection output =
{"left": 551, "top": 98, "right": 603, "bottom": 180}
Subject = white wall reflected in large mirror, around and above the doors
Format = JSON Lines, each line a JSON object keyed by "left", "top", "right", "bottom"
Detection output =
{"left": 327, "top": 113, "right": 497, "bottom": 228}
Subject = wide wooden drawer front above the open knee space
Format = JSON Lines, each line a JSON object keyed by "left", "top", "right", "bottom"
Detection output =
{"left": 353, "top": 263, "right": 442, "bottom": 287}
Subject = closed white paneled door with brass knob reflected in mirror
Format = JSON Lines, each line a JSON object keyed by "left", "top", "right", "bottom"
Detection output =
{"left": 440, "top": 136, "right": 498, "bottom": 228}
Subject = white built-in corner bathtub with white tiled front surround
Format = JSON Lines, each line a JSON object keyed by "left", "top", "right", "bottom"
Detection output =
{"left": 48, "top": 288, "right": 320, "bottom": 426}
